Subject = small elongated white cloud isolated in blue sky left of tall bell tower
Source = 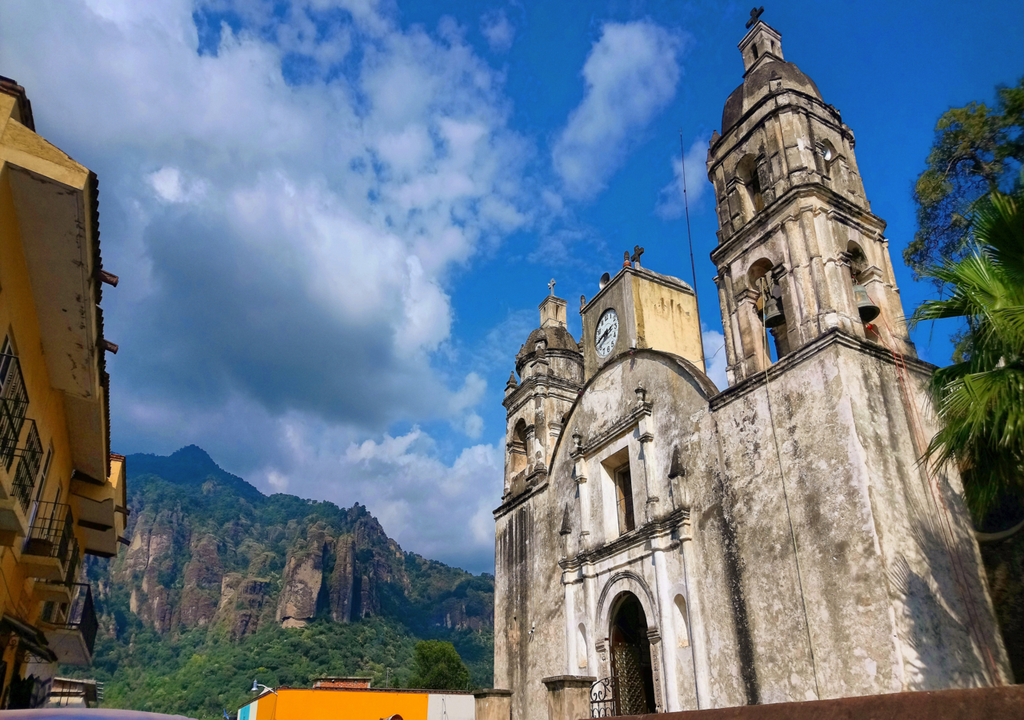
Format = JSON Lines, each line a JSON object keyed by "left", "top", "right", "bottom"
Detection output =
{"left": 552, "top": 20, "right": 683, "bottom": 198}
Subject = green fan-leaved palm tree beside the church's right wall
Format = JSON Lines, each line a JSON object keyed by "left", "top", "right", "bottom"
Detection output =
{"left": 910, "top": 190, "right": 1024, "bottom": 520}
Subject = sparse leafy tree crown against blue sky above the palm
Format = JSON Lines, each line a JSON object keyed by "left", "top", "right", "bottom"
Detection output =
{"left": 903, "top": 78, "right": 1024, "bottom": 277}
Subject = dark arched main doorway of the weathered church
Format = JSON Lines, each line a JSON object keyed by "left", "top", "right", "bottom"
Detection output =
{"left": 608, "top": 592, "right": 655, "bottom": 715}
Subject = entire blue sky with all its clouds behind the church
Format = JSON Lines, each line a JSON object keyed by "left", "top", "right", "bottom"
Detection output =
{"left": 0, "top": 0, "right": 1024, "bottom": 570}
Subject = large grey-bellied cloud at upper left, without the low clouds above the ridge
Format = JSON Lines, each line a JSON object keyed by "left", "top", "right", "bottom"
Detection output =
{"left": 0, "top": 0, "right": 531, "bottom": 432}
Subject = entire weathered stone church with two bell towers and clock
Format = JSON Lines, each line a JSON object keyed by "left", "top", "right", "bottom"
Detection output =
{"left": 495, "top": 12, "right": 1012, "bottom": 720}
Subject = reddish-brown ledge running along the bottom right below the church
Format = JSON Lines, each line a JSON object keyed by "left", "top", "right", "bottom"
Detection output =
{"left": 606, "top": 685, "right": 1024, "bottom": 720}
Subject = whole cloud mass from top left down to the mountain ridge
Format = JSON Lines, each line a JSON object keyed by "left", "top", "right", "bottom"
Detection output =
{"left": 0, "top": 0, "right": 542, "bottom": 569}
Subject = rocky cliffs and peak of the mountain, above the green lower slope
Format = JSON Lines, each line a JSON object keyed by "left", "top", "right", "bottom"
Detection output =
{"left": 98, "top": 446, "right": 494, "bottom": 638}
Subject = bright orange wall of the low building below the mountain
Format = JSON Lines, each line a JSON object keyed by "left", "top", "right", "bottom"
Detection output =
{"left": 241, "top": 689, "right": 428, "bottom": 720}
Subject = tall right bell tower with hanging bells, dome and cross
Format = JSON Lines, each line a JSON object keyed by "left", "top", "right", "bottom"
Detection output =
{"left": 708, "top": 11, "right": 915, "bottom": 385}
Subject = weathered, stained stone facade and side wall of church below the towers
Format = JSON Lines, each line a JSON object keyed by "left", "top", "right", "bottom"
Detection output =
{"left": 495, "top": 340, "right": 1009, "bottom": 719}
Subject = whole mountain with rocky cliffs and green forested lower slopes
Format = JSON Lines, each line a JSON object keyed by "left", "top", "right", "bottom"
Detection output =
{"left": 77, "top": 446, "right": 494, "bottom": 718}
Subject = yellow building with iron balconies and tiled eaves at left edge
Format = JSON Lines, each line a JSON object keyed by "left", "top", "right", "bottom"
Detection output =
{"left": 0, "top": 77, "right": 128, "bottom": 708}
